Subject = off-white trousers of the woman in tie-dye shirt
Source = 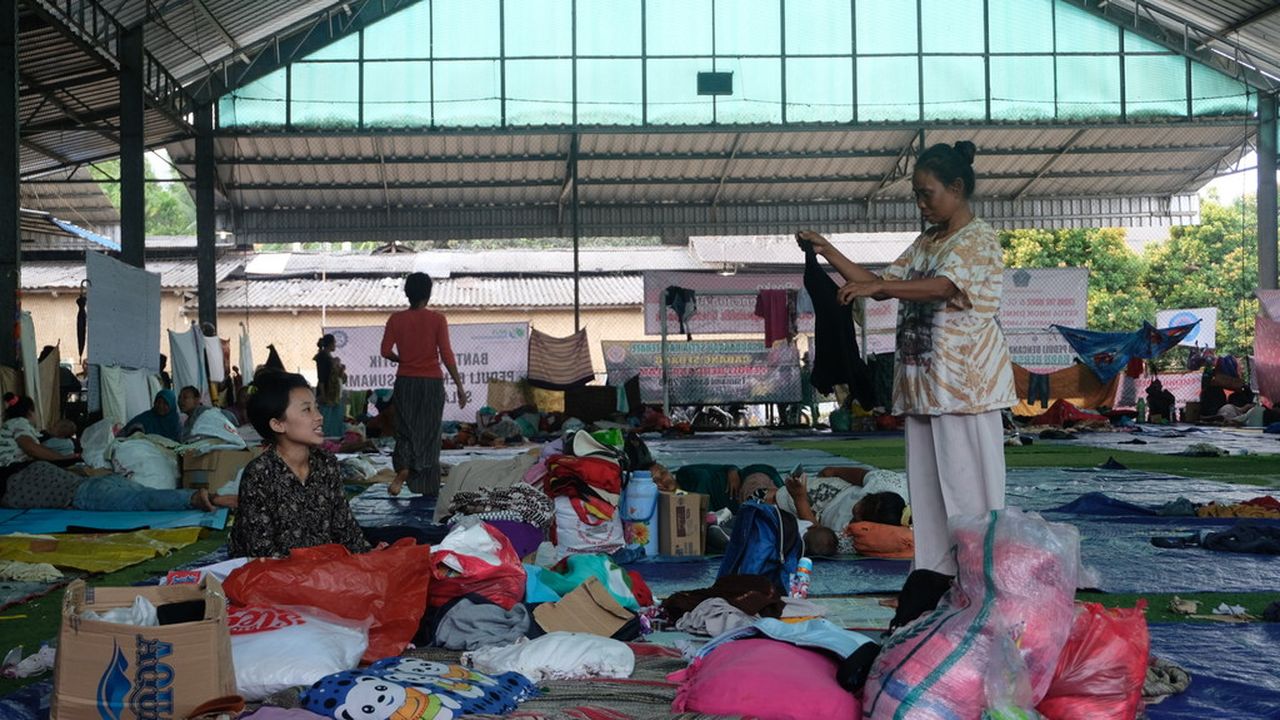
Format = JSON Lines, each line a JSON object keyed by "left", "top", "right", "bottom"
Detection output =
{"left": 906, "top": 410, "right": 1005, "bottom": 575}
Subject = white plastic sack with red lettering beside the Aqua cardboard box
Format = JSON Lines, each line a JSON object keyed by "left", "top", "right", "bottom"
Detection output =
{"left": 227, "top": 607, "right": 369, "bottom": 701}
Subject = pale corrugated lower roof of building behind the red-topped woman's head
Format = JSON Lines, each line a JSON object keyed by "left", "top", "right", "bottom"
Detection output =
{"left": 218, "top": 274, "right": 644, "bottom": 310}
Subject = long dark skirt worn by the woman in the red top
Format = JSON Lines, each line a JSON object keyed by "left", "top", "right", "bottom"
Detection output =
{"left": 392, "top": 375, "right": 444, "bottom": 496}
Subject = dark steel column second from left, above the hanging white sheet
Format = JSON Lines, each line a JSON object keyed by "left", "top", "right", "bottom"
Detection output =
{"left": 120, "top": 27, "right": 147, "bottom": 268}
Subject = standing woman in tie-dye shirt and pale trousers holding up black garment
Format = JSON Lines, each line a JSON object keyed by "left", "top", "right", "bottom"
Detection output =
{"left": 797, "top": 141, "right": 1018, "bottom": 624}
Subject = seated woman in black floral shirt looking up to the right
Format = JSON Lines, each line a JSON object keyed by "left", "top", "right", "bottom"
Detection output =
{"left": 229, "top": 373, "right": 369, "bottom": 557}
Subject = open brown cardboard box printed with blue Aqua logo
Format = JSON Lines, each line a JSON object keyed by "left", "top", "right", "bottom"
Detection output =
{"left": 50, "top": 578, "right": 236, "bottom": 720}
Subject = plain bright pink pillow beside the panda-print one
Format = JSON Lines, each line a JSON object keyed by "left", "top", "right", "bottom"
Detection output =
{"left": 667, "top": 638, "right": 863, "bottom": 720}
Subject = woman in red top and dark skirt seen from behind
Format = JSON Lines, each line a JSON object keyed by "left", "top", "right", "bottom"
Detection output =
{"left": 383, "top": 273, "right": 467, "bottom": 496}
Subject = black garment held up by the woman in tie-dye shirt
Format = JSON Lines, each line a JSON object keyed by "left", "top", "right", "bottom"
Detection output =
{"left": 804, "top": 250, "right": 875, "bottom": 410}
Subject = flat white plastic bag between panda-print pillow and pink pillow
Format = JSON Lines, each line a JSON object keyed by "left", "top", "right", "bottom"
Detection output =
{"left": 462, "top": 633, "right": 636, "bottom": 683}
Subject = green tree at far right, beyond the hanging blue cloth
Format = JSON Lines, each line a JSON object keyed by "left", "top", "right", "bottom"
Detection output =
{"left": 1143, "top": 196, "right": 1258, "bottom": 355}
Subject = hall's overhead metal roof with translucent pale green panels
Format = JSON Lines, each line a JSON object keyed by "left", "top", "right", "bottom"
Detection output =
{"left": 19, "top": 0, "right": 1280, "bottom": 242}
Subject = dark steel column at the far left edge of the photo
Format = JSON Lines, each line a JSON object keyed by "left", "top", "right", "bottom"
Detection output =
{"left": 0, "top": 3, "right": 22, "bottom": 366}
